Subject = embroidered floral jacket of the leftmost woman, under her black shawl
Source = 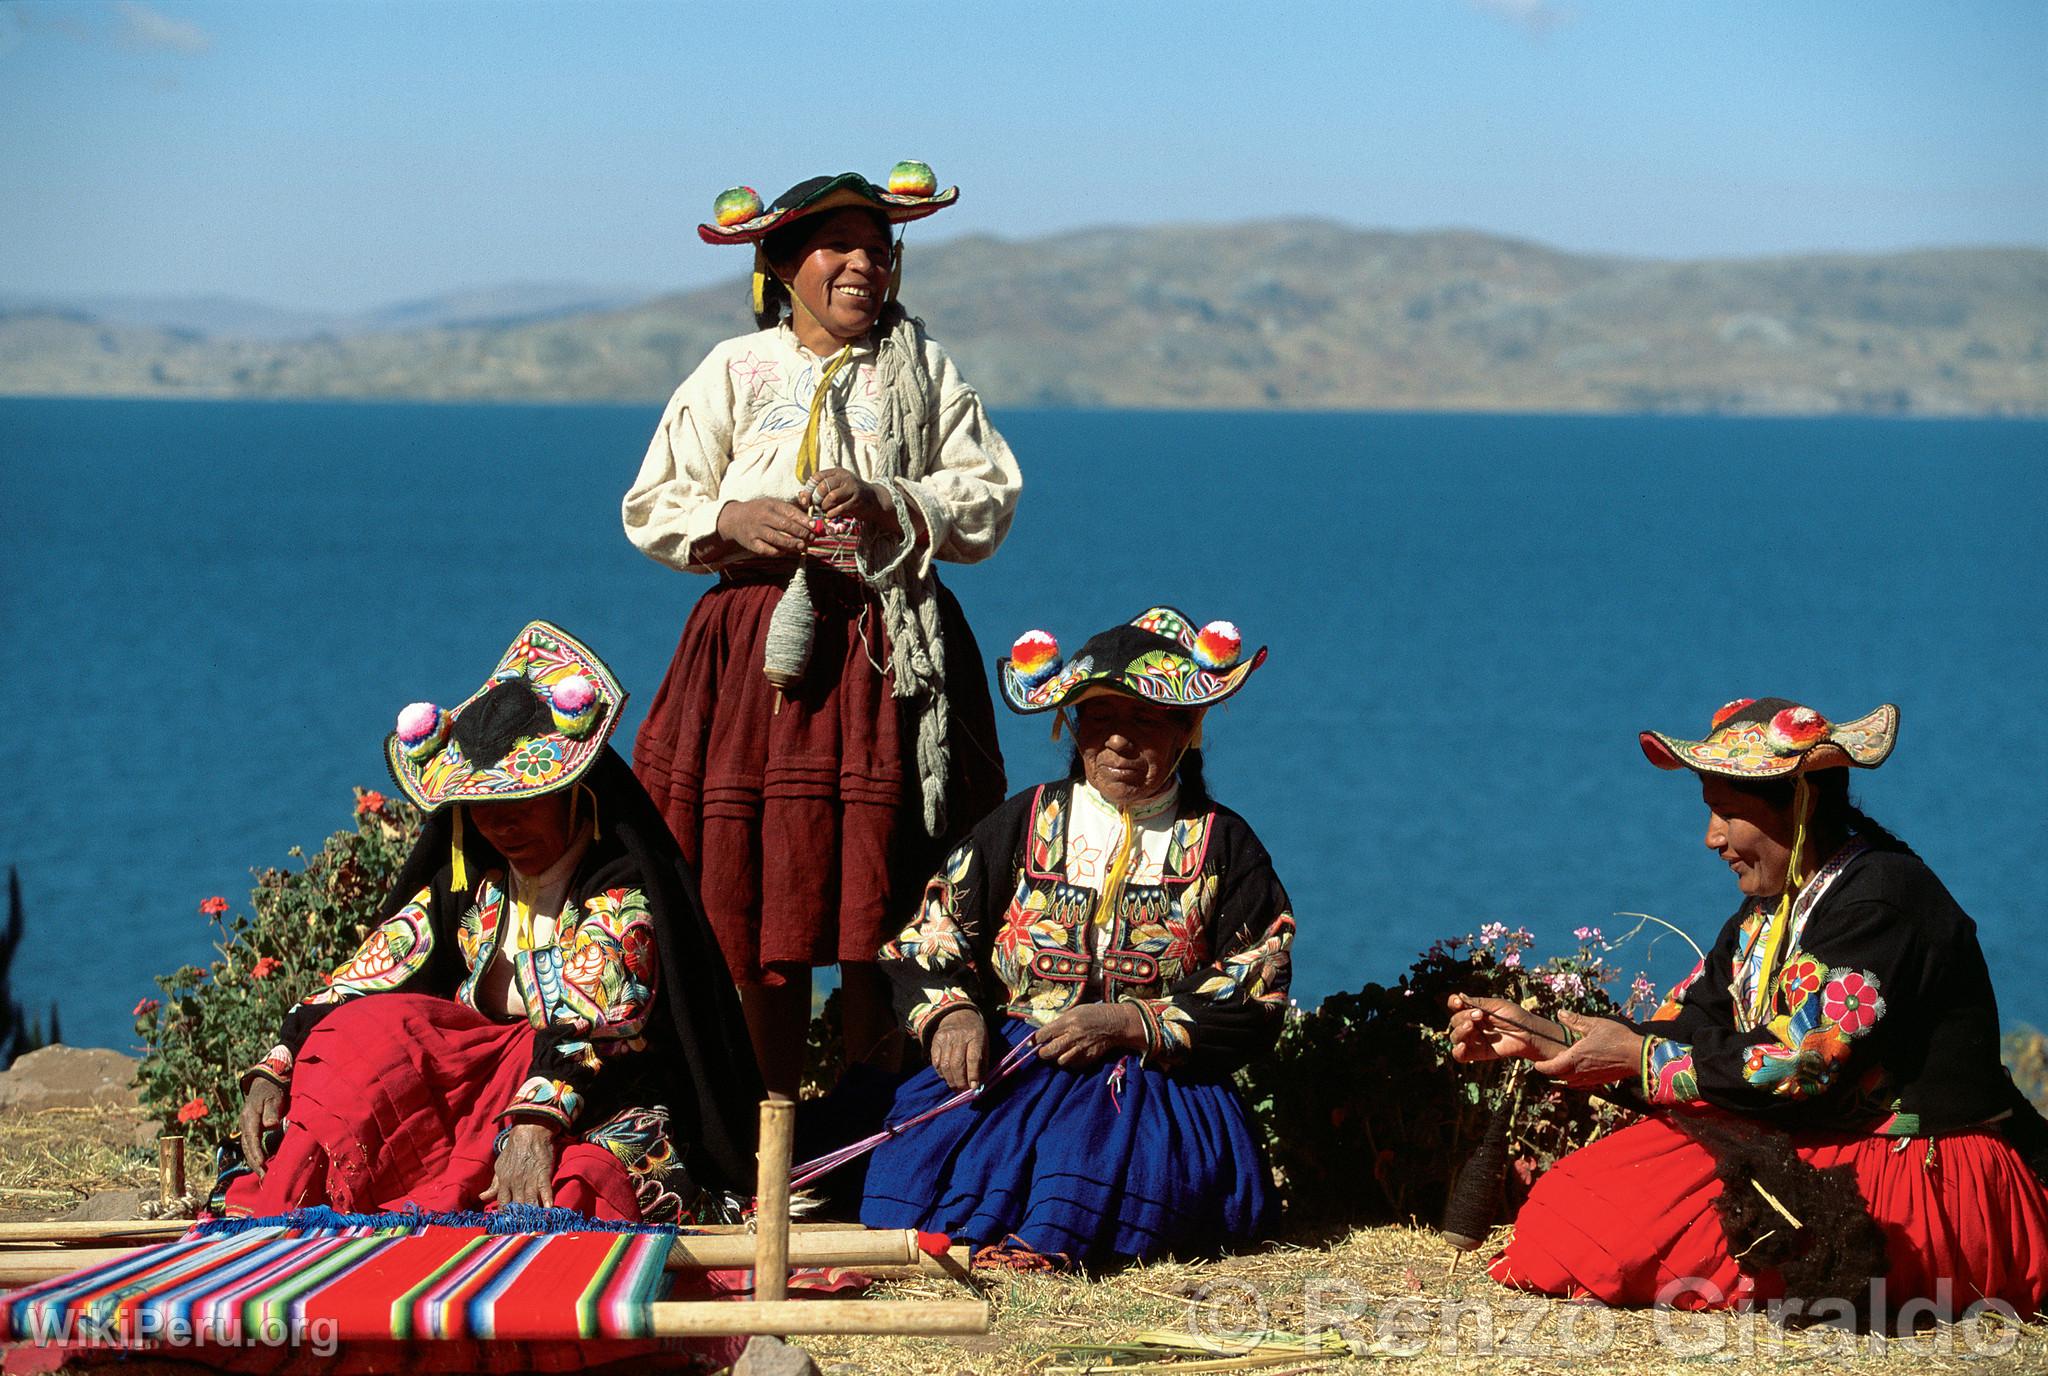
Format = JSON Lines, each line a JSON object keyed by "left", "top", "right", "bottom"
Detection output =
{"left": 244, "top": 848, "right": 659, "bottom": 1159}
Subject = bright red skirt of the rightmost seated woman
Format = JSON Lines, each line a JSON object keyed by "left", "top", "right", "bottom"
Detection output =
{"left": 1491, "top": 1116, "right": 2048, "bottom": 1317}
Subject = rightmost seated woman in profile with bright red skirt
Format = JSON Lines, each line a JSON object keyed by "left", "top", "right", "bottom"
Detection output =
{"left": 1450, "top": 698, "right": 2048, "bottom": 1325}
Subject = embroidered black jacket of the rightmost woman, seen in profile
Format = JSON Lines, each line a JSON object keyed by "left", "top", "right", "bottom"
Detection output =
{"left": 1634, "top": 842, "right": 2015, "bottom": 1136}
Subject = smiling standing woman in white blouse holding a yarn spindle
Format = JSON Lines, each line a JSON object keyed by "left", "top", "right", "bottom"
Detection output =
{"left": 625, "top": 162, "right": 1022, "bottom": 1095}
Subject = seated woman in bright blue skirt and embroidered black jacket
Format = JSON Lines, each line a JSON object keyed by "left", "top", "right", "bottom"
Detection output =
{"left": 860, "top": 608, "right": 1294, "bottom": 1263}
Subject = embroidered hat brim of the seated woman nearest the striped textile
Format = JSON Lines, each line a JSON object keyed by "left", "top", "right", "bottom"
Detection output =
{"left": 385, "top": 620, "right": 627, "bottom": 811}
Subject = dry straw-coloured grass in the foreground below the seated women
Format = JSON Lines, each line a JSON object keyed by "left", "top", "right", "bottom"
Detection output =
{"left": 803, "top": 1229, "right": 2048, "bottom": 1376}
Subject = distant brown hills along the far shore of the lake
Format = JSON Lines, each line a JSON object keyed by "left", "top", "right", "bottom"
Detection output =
{"left": 0, "top": 221, "right": 2048, "bottom": 416}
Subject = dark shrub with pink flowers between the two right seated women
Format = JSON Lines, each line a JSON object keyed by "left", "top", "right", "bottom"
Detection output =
{"left": 1239, "top": 923, "right": 1655, "bottom": 1227}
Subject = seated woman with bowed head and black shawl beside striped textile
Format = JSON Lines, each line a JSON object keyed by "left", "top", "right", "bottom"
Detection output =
{"left": 227, "top": 620, "right": 762, "bottom": 1222}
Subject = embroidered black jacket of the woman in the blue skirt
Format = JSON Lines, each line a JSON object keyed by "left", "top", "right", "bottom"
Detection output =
{"left": 881, "top": 780, "right": 1294, "bottom": 1071}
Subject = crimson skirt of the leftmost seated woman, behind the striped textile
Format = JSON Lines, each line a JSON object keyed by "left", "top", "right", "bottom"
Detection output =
{"left": 227, "top": 993, "right": 641, "bottom": 1222}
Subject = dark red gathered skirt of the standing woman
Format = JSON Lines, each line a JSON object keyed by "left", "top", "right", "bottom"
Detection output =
{"left": 633, "top": 565, "right": 1004, "bottom": 983}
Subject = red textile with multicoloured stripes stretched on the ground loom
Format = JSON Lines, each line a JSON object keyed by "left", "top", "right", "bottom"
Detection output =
{"left": 0, "top": 1227, "right": 670, "bottom": 1347}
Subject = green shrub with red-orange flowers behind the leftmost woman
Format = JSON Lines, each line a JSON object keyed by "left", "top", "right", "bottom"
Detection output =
{"left": 135, "top": 788, "right": 420, "bottom": 1151}
